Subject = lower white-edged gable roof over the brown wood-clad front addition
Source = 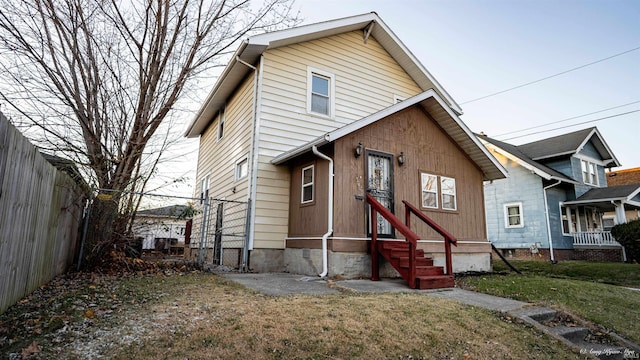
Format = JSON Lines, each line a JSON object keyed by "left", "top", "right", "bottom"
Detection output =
{"left": 271, "top": 89, "right": 508, "bottom": 180}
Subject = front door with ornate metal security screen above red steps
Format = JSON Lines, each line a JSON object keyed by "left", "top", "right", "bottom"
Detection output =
{"left": 366, "top": 150, "right": 395, "bottom": 237}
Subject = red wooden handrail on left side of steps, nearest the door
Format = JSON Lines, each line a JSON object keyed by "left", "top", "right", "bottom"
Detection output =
{"left": 367, "top": 194, "right": 419, "bottom": 289}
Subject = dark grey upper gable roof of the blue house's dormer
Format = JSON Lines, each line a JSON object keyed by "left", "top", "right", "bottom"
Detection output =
{"left": 518, "top": 127, "right": 620, "bottom": 167}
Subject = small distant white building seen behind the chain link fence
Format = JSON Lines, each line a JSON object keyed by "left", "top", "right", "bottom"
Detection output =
{"left": 133, "top": 205, "right": 191, "bottom": 253}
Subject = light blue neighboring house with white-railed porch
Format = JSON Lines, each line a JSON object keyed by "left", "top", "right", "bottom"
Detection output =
{"left": 478, "top": 127, "right": 640, "bottom": 261}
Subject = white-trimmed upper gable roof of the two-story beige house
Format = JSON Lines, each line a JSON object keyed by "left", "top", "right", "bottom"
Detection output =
{"left": 185, "top": 12, "right": 462, "bottom": 137}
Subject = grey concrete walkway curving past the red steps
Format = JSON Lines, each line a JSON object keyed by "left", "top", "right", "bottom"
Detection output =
{"left": 216, "top": 272, "right": 640, "bottom": 359}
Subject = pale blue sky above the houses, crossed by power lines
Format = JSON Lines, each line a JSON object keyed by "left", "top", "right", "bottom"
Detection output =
{"left": 160, "top": 0, "right": 640, "bottom": 202}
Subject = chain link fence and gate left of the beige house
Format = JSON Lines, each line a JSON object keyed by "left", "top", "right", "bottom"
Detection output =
{"left": 81, "top": 189, "right": 250, "bottom": 272}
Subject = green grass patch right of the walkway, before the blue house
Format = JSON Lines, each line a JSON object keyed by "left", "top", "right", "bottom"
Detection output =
{"left": 456, "top": 261, "right": 640, "bottom": 343}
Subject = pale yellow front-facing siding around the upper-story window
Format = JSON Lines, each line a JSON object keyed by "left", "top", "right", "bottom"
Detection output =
{"left": 254, "top": 31, "right": 422, "bottom": 248}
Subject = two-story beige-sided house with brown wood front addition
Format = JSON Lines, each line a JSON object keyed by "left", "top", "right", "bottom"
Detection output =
{"left": 186, "top": 13, "right": 506, "bottom": 284}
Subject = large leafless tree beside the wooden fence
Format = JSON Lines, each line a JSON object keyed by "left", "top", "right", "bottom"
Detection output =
{"left": 0, "top": 0, "right": 298, "bottom": 263}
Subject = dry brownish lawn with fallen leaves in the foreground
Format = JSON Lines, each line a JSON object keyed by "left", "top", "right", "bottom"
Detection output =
{"left": 0, "top": 272, "right": 581, "bottom": 359}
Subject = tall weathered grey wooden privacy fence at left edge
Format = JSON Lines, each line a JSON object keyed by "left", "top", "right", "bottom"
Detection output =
{"left": 0, "top": 113, "right": 85, "bottom": 313}
